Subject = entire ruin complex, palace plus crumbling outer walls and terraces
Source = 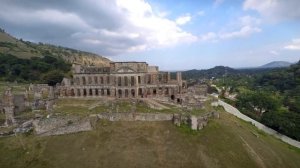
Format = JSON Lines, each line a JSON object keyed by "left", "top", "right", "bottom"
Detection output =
{"left": 0, "top": 62, "right": 218, "bottom": 135}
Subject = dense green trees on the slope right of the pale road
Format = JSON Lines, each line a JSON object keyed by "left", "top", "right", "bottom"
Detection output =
{"left": 216, "top": 61, "right": 300, "bottom": 140}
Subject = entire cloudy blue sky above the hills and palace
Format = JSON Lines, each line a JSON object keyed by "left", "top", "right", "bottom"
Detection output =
{"left": 0, "top": 0, "right": 300, "bottom": 70}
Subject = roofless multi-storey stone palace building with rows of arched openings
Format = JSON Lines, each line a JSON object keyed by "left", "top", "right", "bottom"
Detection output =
{"left": 56, "top": 62, "right": 186, "bottom": 102}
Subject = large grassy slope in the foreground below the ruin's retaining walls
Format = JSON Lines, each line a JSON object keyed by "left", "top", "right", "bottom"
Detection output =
{"left": 0, "top": 110, "right": 300, "bottom": 168}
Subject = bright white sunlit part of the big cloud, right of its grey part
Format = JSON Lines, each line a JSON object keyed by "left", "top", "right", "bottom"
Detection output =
{"left": 117, "top": 0, "right": 197, "bottom": 47}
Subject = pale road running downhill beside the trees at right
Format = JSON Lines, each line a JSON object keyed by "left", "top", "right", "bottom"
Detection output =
{"left": 217, "top": 100, "right": 300, "bottom": 148}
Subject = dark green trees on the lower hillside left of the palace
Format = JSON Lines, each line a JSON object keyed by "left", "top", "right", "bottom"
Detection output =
{"left": 0, "top": 53, "right": 71, "bottom": 85}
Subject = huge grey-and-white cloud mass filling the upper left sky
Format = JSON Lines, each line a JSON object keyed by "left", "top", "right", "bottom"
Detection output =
{"left": 0, "top": 0, "right": 197, "bottom": 56}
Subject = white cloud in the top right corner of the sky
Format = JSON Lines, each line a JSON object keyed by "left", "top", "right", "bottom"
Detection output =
{"left": 243, "top": 0, "right": 300, "bottom": 22}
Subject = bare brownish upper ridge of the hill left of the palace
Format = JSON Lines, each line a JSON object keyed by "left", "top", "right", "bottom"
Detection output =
{"left": 0, "top": 29, "right": 111, "bottom": 66}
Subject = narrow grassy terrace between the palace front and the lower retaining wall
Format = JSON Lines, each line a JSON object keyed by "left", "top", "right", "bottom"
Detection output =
{"left": 54, "top": 98, "right": 213, "bottom": 115}
